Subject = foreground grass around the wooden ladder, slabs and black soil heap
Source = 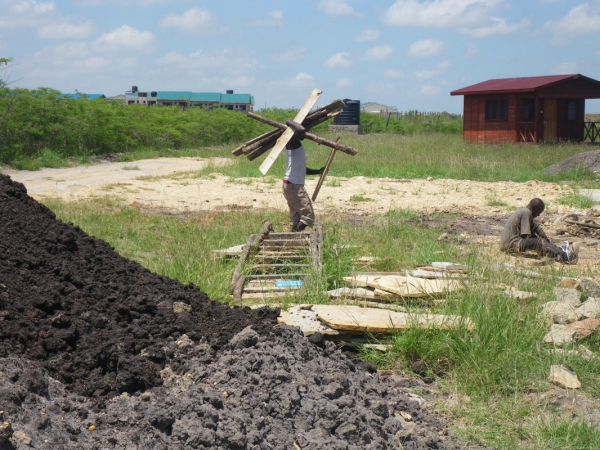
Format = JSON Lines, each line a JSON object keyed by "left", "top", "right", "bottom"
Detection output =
{"left": 47, "top": 200, "right": 600, "bottom": 450}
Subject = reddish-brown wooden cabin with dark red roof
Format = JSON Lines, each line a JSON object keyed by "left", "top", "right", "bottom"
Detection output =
{"left": 450, "top": 75, "right": 600, "bottom": 143}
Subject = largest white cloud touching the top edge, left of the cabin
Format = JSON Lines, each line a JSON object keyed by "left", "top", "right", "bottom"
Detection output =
{"left": 382, "top": 0, "right": 529, "bottom": 37}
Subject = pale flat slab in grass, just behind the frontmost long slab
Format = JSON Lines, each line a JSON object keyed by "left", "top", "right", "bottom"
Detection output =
{"left": 344, "top": 274, "right": 464, "bottom": 297}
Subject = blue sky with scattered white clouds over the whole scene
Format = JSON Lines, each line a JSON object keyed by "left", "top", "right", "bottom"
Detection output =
{"left": 0, "top": 0, "right": 600, "bottom": 113}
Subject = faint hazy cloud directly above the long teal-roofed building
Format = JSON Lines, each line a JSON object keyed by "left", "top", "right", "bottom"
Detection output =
{"left": 155, "top": 48, "right": 259, "bottom": 72}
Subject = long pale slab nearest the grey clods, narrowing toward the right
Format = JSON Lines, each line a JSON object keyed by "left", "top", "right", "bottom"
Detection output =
{"left": 312, "top": 305, "right": 475, "bottom": 333}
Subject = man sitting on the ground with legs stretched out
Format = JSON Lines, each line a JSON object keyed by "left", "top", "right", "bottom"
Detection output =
{"left": 500, "top": 198, "right": 580, "bottom": 264}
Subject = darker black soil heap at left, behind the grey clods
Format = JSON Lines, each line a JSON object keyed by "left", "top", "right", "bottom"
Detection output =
{"left": 0, "top": 175, "right": 276, "bottom": 396}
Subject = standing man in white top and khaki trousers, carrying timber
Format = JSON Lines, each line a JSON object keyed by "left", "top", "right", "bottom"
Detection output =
{"left": 283, "top": 119, "right": 325, "bottom": 231}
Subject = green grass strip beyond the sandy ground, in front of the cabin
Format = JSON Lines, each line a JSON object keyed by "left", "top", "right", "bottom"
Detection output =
{"left": 89, "top": 133, "right": 597, "bottom": 184}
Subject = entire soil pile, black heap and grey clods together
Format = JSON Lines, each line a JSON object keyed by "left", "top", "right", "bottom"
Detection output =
{"left": 0, "top": 175, "right": 490, "bottom": 450}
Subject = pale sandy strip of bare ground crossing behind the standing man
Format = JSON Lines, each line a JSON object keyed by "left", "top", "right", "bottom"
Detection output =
{"left": 5, "top": 158, "right": 588, "bottom": 216}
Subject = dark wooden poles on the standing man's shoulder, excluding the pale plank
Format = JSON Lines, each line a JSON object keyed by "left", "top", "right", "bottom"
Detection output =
{"left": 232, "top": 100, "right": 358, "bottom": 161}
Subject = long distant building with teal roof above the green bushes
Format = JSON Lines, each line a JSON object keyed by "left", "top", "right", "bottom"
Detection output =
{"left": 110, "top": 86, "right": 254, "bottom": 112}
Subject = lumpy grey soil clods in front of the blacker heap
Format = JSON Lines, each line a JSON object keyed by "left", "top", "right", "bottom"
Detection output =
{"left": 0, "top": 325, "right": 490, "bottom": 450}
